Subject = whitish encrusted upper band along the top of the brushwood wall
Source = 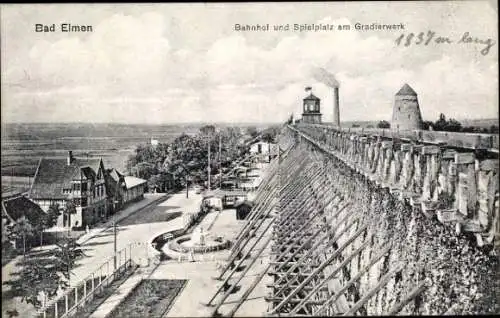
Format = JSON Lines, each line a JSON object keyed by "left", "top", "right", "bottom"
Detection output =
{"left": 292, "top": 125, "right": 500, "bottom": 246}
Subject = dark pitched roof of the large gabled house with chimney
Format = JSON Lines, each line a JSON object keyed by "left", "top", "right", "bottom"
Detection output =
{"left": 29, "top": 158, "right": 105, "bottom": 199}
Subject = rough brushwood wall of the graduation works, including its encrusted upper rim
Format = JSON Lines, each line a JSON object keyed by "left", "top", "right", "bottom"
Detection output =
{"left": 288, "top": 126, "right": 500, "bottom": 315}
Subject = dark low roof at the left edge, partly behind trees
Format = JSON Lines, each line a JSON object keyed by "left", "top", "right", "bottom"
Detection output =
{"left": 2, "top": 196, "right": 45, "bottom": 225}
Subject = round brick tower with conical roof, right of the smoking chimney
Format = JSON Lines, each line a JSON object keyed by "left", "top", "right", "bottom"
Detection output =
{"left": 391, "top": 84, "right": 422, "bottom": 130}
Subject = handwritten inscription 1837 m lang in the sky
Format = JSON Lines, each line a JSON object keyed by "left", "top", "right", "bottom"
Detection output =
{"left": 395, "top": 31, "right": 496, "bottom": 55}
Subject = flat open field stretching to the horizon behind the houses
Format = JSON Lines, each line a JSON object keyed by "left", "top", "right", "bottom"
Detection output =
{"left": 1, "top": 124, "right": 205, "bottom": 177}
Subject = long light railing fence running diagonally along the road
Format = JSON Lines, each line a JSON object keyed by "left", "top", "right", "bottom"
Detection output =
{"left": 36, "top": 243, "right": 149, "bottom": 318}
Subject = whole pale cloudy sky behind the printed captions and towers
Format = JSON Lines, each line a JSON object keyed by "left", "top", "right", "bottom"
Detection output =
{"left": 0, "top": 1, "right": 499, "bottom": 124}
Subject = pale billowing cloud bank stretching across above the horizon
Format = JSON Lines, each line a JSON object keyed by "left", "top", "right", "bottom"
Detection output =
{"left": 2, "top": 12, "right": 498, "bottom": 123}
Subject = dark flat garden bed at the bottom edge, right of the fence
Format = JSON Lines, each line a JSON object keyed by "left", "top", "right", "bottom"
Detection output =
{"left": 107, "top": 279, "right": 187, "bottom": 318}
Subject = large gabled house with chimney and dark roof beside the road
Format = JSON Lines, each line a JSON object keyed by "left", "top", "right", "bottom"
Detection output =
{"left": 29, "top": 151, "right": 108, "bottom": 228}
